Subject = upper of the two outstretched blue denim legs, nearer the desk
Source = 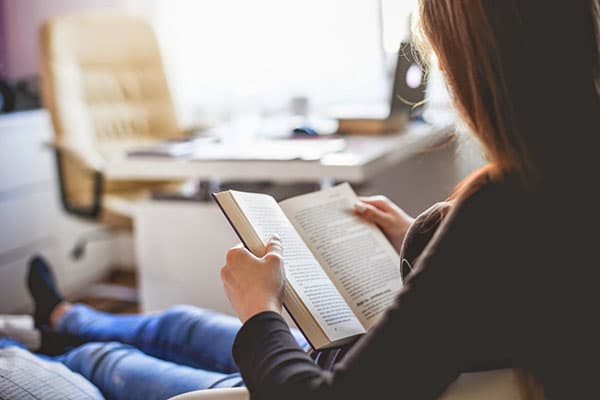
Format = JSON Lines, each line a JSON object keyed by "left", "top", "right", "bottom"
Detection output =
{"left": 57, "top": 304, "right": 308, "bottom": 373}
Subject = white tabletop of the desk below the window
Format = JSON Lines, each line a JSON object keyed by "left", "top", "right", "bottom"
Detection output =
{"left": 103, "top": 124, "right": 453, "bottom": 183}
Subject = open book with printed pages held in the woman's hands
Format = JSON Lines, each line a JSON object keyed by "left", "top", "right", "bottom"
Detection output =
{"left": 213, "top": 184, "right": 402, "bottom": 350}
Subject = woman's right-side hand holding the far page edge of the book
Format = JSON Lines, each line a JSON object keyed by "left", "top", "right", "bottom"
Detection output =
{"left": 354, "top": 196, "right": 414, "bottom": 253}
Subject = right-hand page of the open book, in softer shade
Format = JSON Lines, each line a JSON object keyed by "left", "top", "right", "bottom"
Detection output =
{"left": 280, "top": 184, "right": 402, "bottom": 329}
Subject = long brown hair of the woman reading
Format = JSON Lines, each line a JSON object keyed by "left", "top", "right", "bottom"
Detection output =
{"left": 420, "top": 0, "right": 600, "bottom": 194}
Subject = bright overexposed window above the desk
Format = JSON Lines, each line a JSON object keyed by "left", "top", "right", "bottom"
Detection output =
{"left": 145, "top": 0, "right": 398, "bottom": 123}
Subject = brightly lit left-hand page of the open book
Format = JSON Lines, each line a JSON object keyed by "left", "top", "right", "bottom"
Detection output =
{"left": 232, "top": 191, "right": 365, "bottom": 341}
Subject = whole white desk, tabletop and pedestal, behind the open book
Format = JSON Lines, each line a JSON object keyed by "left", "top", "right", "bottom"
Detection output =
{"left": 129, "top": 121, "right": 466, "bottom": 313}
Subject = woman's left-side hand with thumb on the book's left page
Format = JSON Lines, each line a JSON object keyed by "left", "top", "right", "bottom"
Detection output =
{"left": 221, "top": 237, "right": 285, "bottom": 322}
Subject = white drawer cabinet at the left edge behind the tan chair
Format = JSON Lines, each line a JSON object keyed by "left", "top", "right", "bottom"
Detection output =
{"left": 0, "top": 110, "right": 119, "bottom": 313}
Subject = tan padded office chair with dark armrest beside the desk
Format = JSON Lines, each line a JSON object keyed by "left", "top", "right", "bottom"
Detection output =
{"left": 40, "top": 10, "right": 189, "bottom": 242}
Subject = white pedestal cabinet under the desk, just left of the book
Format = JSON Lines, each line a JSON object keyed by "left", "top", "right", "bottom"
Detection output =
{"left": 135, "top": 200, "right": 239, "bottom": 314}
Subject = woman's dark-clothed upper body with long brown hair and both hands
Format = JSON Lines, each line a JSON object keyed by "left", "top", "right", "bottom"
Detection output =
{"left": 222, "top": 0, "right": 600, "bottom": 400}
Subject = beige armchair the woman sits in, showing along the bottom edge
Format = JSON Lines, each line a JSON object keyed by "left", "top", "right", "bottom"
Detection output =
{"left": 171, "top": 369, "right": 530, "bottom": 400}
